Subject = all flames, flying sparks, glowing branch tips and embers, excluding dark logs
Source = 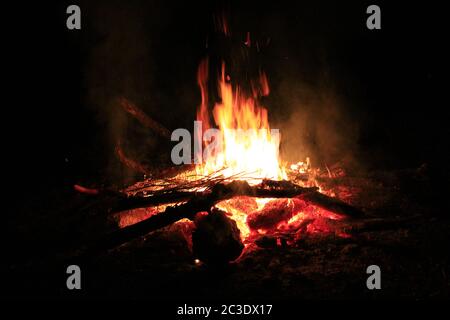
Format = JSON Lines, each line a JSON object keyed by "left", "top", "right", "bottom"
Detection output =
{"left": 110, "top": 15, "right": 352, "bottom": 265}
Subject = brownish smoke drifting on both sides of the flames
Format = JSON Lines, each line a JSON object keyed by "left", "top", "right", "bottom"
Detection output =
{"left": 81, "top": 1, "right": 366, "bottom": 181}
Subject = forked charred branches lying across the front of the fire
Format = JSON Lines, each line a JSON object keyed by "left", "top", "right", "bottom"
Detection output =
{"left": 79, "top": 180, "right": 360, "bottom": 253}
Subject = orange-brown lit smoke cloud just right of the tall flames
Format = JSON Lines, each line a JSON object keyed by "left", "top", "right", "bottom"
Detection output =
{"left": 279, "top": 81, "right": 359, "bottom": 170}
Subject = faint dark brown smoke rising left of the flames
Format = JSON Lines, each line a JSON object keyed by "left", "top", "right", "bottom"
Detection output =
{"left": 82, "top": 1, "right": 176, "bottom": 182}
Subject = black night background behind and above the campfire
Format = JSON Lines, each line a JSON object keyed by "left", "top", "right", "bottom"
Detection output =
{"left": 2, "top": 1, "right": 449, "bottom": 300}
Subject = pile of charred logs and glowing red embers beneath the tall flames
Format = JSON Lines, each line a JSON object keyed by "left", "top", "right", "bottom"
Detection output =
{"left": 76, "top": 170, "right": 363, "bottom": 263}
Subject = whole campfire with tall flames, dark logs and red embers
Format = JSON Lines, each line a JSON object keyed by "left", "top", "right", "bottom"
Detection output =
{"left": 76, "top": 16, "right": 362, "bottom": 264}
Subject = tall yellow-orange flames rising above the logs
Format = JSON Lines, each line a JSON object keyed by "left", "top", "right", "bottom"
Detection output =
{"left": 196, "top": 60, "right": 287, "bottom": 184}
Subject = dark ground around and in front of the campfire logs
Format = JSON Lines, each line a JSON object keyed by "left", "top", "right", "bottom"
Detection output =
{"left": 2, "top": 165, "right": 450, "bottom": 301}
